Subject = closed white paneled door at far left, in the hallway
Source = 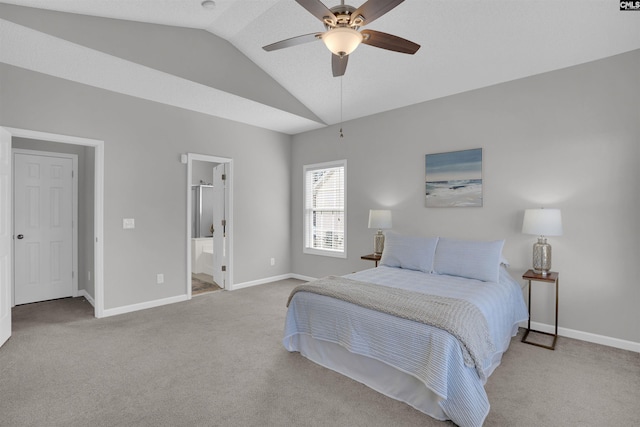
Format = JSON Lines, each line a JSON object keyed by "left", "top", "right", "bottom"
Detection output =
{"left": 13, "top": 153, "right": 74, "bottom": 304}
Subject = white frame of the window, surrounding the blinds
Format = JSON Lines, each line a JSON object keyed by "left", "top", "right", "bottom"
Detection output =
{"left": 302, "top": 159, "right": 347, "bottom": 258}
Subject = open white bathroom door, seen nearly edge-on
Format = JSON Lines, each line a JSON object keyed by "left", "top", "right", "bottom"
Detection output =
{"left": 213, "top": 163, "right": 227, "bottom": 289}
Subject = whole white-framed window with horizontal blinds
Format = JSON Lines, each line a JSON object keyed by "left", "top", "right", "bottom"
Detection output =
{"left": 304, "top": 160, "right": 347, "bottom": 258}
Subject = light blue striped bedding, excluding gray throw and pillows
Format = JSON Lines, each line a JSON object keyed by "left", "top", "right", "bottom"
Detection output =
{"left": 283, "top": 266, "right": 528, "bottom": 426}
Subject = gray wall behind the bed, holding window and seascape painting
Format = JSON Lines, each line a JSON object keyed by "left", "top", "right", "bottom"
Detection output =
{"left": 291, "top": 51, "right": 640, "bottom": 342}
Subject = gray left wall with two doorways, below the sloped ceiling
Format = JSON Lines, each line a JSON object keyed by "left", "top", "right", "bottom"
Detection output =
{"left": 0, "top": 64, "right": 291, "bottom": 309}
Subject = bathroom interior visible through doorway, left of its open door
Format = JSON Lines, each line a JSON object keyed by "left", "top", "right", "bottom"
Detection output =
{"left": 191, "top": 160, "right": 225, "bottom": 295}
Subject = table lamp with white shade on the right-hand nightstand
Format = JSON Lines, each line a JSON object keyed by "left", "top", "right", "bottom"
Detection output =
{"left": 522, "top": 208, "right": 562, "bottom": 276}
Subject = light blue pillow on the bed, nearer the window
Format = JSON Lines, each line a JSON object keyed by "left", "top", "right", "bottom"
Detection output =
{"left": 380, "top": 233, "right": 438, "bottom": 273}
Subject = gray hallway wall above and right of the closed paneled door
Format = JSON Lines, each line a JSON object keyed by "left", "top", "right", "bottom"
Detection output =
{"left": 11, "top": 138, "right": 95, "bottom": 297}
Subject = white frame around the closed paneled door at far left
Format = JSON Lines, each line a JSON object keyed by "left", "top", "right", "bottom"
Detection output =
{"left": 11, "top": 148, "right": 80, "bottom": 307}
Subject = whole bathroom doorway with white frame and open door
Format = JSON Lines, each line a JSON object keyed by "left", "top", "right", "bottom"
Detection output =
{"left": 187, "top": 153, "right": 231, "bottom": 297}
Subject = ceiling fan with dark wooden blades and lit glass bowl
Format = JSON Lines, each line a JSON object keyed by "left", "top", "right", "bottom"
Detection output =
{"left": 263, "top": 0, "right": 420, "bottom": 77}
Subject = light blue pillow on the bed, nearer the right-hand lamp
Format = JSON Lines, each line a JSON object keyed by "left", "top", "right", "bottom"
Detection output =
{"left": 433, "top": 237, "right": 504, "bottom": 282}
